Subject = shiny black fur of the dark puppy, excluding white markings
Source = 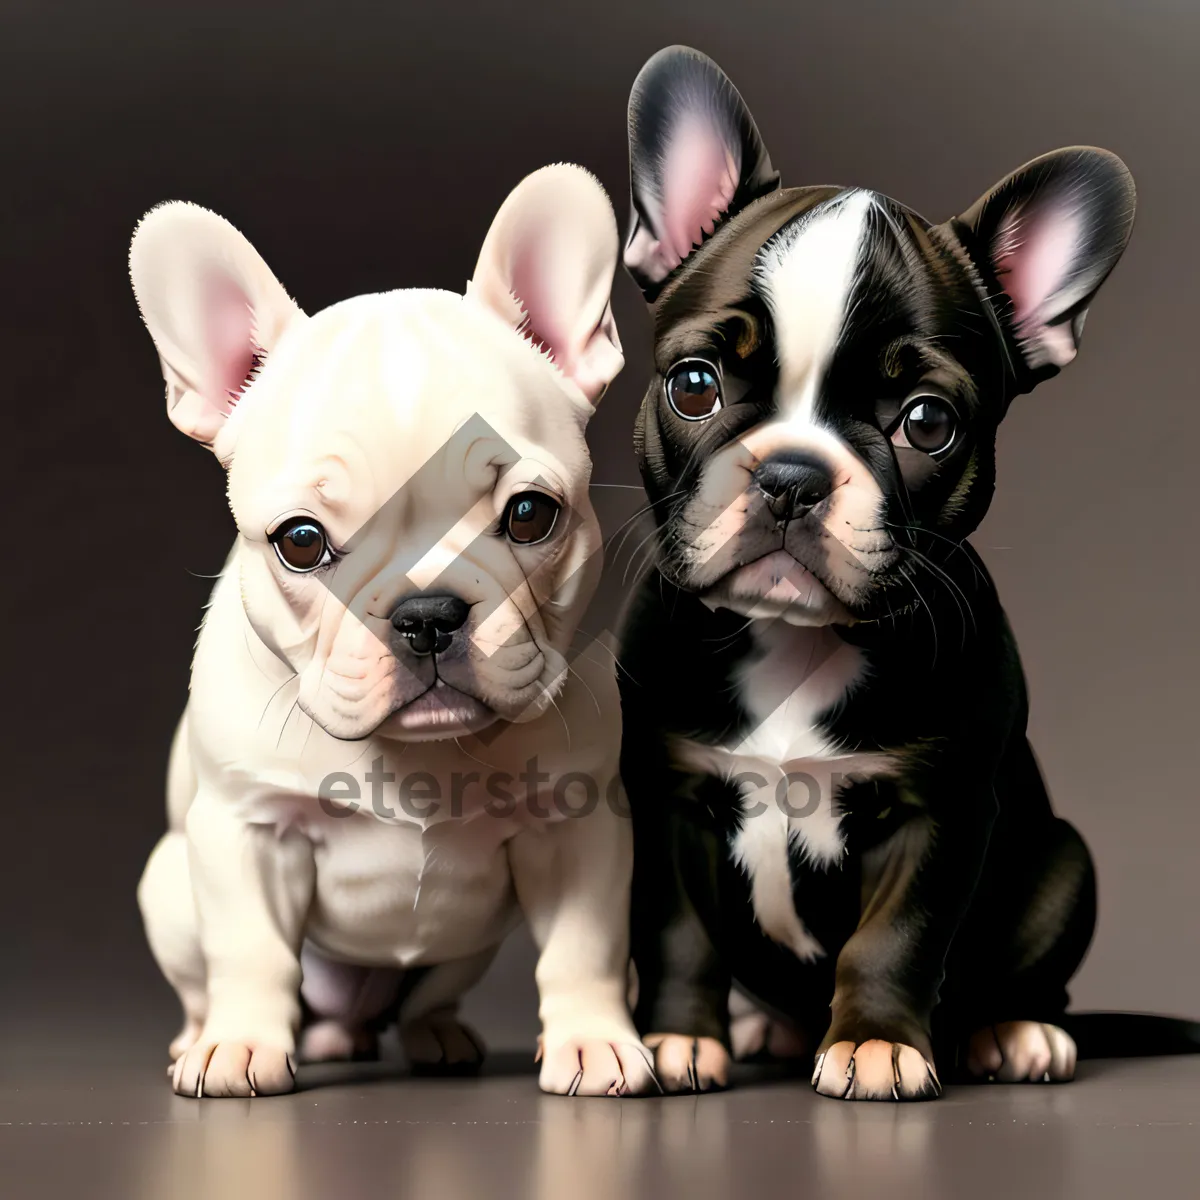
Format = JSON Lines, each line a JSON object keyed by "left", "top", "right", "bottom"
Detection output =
{"left": 620, "top": 48, "right": 1195, "bottom": 1099}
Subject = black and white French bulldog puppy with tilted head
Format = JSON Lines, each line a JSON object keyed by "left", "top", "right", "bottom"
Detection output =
{"left": 622, "top": 47, "right": 1134, "bottom": 1099}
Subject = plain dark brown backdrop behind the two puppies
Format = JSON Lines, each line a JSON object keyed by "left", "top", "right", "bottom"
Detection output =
{"left": 0, "top": 0, "right": 1200, "bottom": 1073}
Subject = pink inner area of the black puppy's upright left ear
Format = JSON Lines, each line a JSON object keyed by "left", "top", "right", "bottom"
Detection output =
{"left": 661, "top": 113, "right": 742, "bottom": 266}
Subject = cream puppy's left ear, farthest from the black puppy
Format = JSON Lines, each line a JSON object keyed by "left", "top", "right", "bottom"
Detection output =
{"left": 130, "top": 202, "right": 301, "bottom": 458}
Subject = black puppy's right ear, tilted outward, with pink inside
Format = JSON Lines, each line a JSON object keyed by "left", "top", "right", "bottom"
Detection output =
{"left": 949, "top": 146, "right": 1135, "bottom": 391}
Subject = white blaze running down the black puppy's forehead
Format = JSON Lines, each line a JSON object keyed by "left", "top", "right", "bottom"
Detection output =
{"left": 757, "top": 191, "right": 875, "bottom": 418}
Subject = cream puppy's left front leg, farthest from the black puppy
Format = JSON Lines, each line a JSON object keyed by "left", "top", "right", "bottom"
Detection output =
{"left": 174, "top": 791, "right": 316, "bottom": 1097}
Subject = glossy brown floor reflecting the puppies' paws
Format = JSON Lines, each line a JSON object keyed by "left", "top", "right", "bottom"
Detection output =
{"left": 0, "top": 1048, "right": 1200, "bottom": 1200}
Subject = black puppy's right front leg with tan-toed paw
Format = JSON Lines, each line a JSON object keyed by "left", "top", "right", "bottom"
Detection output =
{"left": 812, "top": 786, "right": 996, "bottom": 1100}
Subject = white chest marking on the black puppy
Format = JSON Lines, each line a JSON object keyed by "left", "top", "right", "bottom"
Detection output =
{"left": 677, "top": 622, "right": 896, "bottom": 961}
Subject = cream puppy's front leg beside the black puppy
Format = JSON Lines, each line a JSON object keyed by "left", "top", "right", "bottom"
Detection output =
{"left": 509, "top": 785, "right": 656, "bottom": 1096}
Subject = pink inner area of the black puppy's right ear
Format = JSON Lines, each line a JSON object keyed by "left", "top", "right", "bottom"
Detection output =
{"left": 995, "top": 200, "right": 1081, "bottom": 326}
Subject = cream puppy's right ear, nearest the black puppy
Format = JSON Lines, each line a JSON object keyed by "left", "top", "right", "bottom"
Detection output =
{"left": 467, "top": 163, "right": 625, "bottom": 404}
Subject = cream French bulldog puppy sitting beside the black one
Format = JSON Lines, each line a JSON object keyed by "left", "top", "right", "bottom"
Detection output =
{"left": 130, "top": 166, "right": 655, "bottom": 1097}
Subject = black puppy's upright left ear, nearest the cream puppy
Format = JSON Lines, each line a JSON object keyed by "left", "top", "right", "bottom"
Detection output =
{"left": 625, "top": 46, "right": 779, "bottom": 300}
